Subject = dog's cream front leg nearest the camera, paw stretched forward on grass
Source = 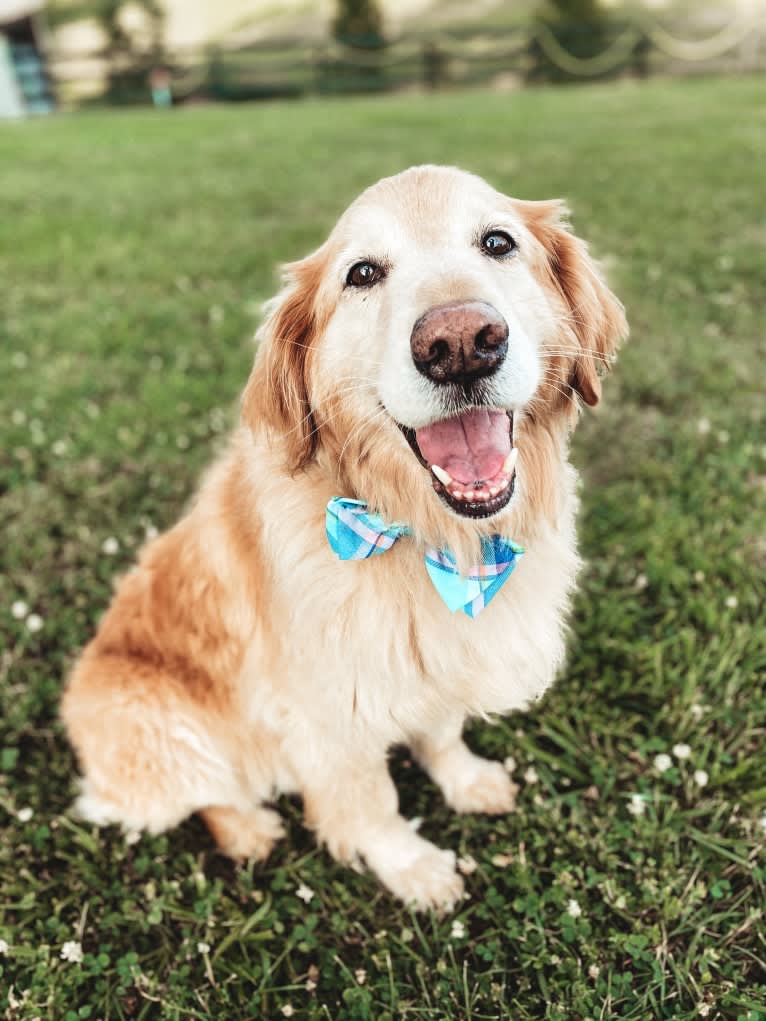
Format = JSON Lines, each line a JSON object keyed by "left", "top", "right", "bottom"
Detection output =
{"left": 302, "top": 748, "right": 463, "bottom": 911}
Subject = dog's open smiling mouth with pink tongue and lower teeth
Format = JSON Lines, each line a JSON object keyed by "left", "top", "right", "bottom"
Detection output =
{"left": 401, "top": 407, "right": 518, "bottom": 518}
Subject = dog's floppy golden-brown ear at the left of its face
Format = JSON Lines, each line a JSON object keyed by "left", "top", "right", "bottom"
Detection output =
{"left": 242, "top": 249, "right": 325, "bottom": 472}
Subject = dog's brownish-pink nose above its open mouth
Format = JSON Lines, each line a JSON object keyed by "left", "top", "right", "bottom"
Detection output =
{"left": 410, "top": 301, "right": 508, "bottom": 383}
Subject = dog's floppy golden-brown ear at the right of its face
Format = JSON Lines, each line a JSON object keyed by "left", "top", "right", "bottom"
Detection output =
{"left": 519, "top": 201, "right": 628, "bottom": 406}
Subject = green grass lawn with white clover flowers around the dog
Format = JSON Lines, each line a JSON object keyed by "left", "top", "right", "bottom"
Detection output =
{"left": 0, "top": 79, "right": 766, "bottom": 1021}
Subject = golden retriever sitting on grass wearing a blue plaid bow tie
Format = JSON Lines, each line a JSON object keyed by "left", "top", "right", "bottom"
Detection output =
{"left": 62, "top": 166, "right": 627, "bottom": 911}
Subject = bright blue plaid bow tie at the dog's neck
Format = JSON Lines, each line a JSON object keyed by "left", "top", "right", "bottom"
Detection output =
{"left": 326, "top": 496, "right": 524, "bottom": 618}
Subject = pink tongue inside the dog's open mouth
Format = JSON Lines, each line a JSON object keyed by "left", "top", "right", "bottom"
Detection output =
{"left": 415, "top": 407, "right": 511, "bottom": 483}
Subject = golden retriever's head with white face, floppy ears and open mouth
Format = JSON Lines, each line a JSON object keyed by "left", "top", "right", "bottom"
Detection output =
{"left": 243, "top": 166, "right": 627, "bottom": 555}
